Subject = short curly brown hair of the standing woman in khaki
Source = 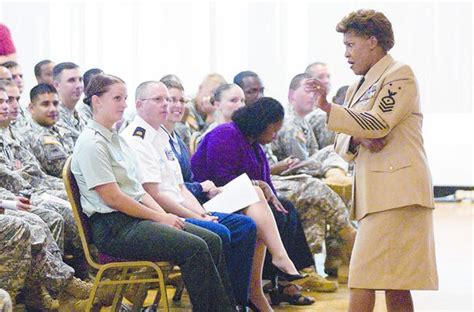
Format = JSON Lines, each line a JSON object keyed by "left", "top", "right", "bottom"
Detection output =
{"left": 336, "top": 10, "right": 395, "bottom": 52}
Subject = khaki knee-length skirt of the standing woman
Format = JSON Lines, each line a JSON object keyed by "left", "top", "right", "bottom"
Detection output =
{"left": 348, "top": 206, "right": 438, "bottom": 290}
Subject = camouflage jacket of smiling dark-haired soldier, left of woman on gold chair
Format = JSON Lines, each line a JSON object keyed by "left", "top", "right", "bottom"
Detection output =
{"left": 24, "top": 120, "right": 74, "bottom": 178}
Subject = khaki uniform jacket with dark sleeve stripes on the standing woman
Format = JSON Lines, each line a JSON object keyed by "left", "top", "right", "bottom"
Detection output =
{"left": 328, "top": 55, "right": 434, "bottom": 220}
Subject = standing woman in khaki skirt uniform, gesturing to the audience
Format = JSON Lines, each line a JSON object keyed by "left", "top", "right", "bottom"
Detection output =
{"left": 306, "top": 10, "right": 438, "bottom": 312}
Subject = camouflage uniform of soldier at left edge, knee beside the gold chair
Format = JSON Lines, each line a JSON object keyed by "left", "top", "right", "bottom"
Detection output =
{"left": 0, "top": 129, "right": 83, "bottom": 255}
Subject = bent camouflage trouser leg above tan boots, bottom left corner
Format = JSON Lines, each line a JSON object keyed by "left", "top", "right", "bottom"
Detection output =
{"left": 3, "top": 211, "right": 74, "bottom": 297}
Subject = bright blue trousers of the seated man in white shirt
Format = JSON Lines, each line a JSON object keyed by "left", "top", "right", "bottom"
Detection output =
{"left": 186, "top": 212, "right": 257, "bottom": 305}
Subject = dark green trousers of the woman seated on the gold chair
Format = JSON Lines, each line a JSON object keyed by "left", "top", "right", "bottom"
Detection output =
{"left": 91, "top": 212, "right": 234, "bottom": 312}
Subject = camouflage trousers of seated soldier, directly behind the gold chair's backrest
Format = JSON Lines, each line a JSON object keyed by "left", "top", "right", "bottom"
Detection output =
{"left": 31, "top": 191, "right": 83, "bottom": 257}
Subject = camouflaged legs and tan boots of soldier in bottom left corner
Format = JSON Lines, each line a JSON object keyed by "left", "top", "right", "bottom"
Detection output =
{"left": 0, "top": 202, "right": 110, "bottom": 311}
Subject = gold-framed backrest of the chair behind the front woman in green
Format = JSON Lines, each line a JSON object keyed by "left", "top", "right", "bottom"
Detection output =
{"left": 63, "top": 156, "right": 100, "bottom": 269}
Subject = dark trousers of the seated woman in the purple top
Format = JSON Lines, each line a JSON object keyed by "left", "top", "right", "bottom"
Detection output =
{"left": 263, "top": 196, "right": 314, "bottom": 279}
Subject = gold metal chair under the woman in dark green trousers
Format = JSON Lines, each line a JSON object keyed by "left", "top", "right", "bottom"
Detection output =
{"left": 63, "top": 157, "right": 173, "bottom": 311}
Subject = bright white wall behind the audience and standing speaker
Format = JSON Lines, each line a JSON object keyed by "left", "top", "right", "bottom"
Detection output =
{"left": 0, "top": 0, "right": 474, "bottom": 185}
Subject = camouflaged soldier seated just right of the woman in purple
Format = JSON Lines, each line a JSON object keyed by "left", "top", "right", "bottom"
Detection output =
{"left": 272, "top": 74, "right": 355, "bottom": 280}
